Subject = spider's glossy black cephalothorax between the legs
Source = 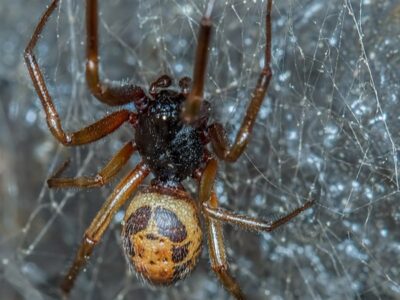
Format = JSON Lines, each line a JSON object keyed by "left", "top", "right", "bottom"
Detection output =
{"left": 135, "top": 90, "right": 204, "bottom": 182}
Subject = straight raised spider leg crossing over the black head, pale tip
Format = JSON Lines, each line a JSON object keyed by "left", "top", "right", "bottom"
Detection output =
{"left": 182, "top": 1, "right": 214, "bottom": 123}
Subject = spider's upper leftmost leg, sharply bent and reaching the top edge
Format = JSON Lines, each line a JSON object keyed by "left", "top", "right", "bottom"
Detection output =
{"left": 24, "top": 0, "right": 135, "bottom": 146}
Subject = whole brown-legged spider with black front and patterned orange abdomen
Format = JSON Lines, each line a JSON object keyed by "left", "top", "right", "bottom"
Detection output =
{"left": 24, "top": 0, "right": 314, "bottom": 299}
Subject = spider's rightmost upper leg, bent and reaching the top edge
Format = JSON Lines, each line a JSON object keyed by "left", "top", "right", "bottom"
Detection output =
{"left": 209, "top": 0, "right": 272, "bottom": 162}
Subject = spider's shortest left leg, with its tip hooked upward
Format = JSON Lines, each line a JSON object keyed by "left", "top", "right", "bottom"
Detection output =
{"left": 47, "top": 142, "right": 136, "bottom": 188}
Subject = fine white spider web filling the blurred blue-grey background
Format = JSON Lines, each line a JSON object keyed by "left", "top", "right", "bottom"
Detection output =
{"left": 0, "top": 0, "right": 400, "bottom": 299}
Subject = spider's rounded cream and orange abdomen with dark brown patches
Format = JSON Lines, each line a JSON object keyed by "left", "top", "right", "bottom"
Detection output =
{"left": 122, "top": 191, "right": 202, "bottom": 285}
